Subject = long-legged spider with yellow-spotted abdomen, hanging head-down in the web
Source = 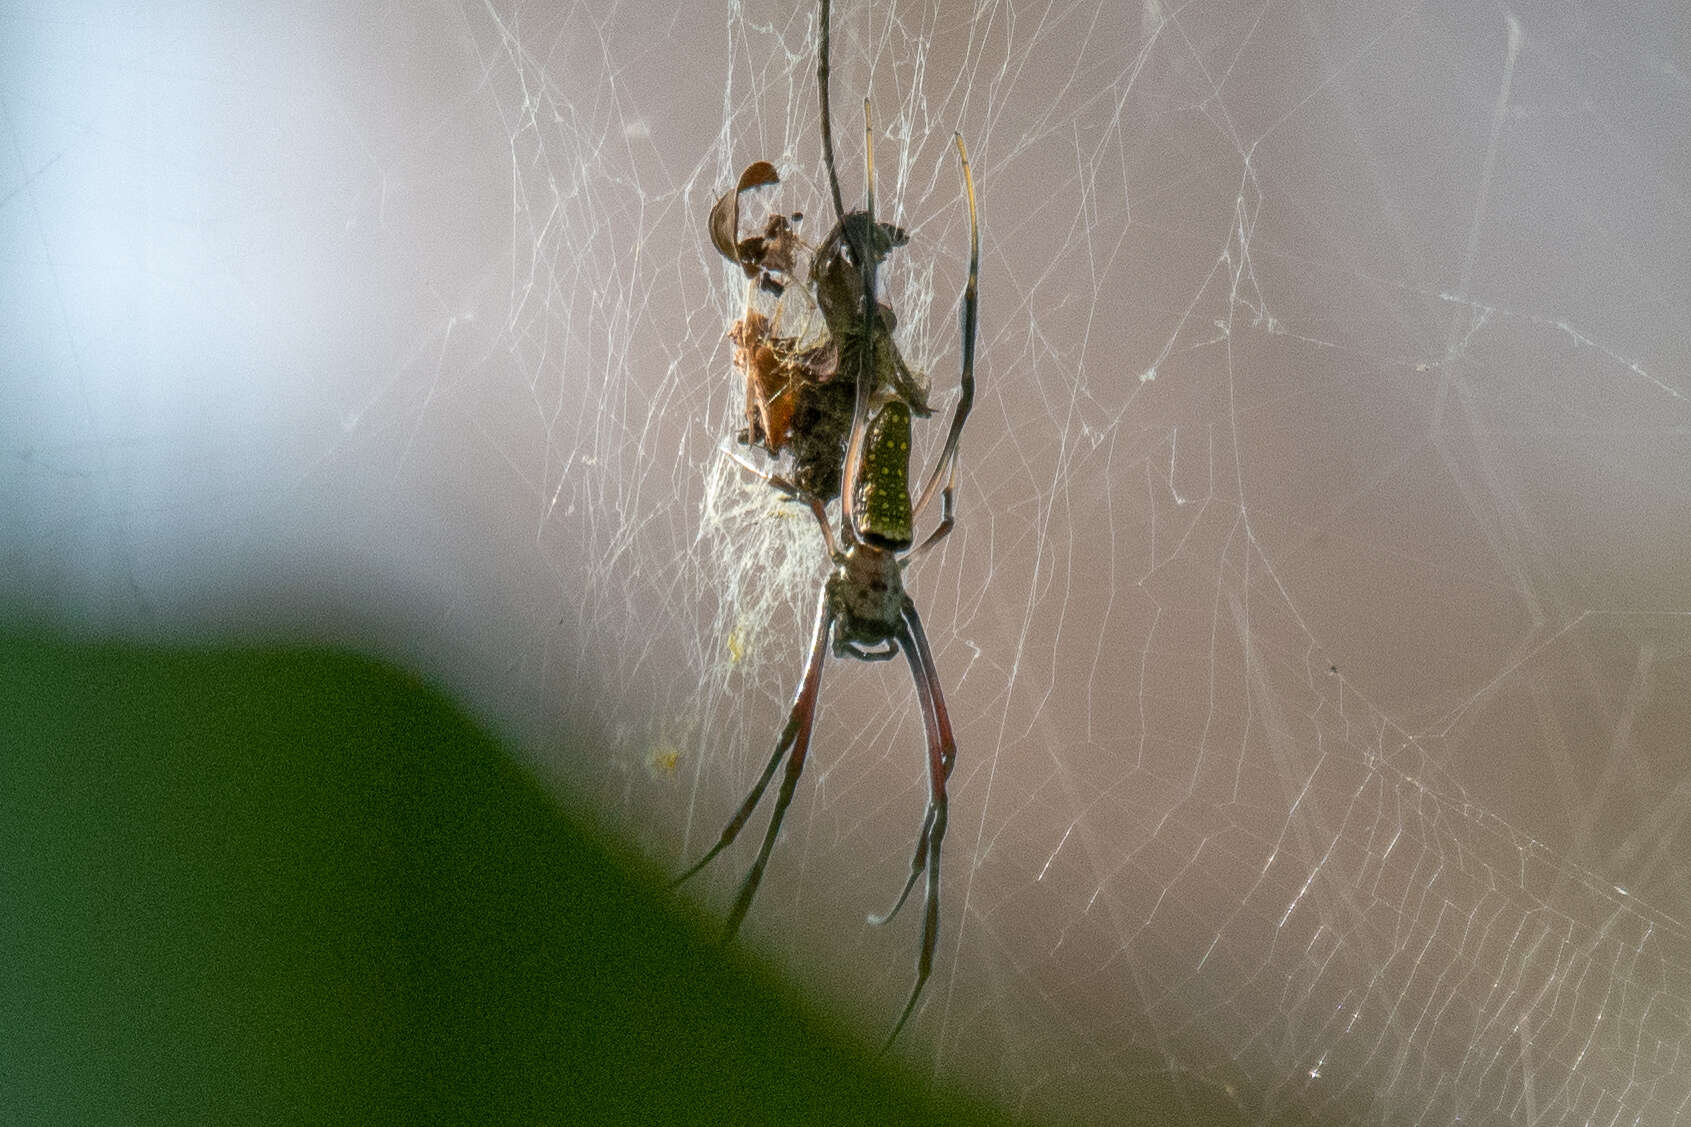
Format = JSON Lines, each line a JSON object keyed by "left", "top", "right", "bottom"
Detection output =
{"left": 675, "top": 0, "right": 981, "bottom": 1053}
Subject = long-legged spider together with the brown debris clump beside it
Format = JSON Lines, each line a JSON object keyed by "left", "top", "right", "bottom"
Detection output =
{"left": 676, "top": 0, "right": 981, "bottom": 1051}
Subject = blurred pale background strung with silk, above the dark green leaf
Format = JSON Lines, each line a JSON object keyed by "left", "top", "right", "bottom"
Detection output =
{"left": 0, "top": 0, "right": 1691, "bottom": 1125}
